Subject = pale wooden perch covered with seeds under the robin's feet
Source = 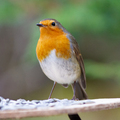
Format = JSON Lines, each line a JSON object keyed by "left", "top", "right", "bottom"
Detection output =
{"left": 0, "top": 98, "right": 120, "bottom": 119}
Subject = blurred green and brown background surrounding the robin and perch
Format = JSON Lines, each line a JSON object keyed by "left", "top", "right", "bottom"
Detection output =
{"left": 0, "top": 0, "right": 120, "bottom": 120}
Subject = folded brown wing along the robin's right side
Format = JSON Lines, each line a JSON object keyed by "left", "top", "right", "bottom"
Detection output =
{"left": 67, "top": 34, "right": 86, "bottom": 88}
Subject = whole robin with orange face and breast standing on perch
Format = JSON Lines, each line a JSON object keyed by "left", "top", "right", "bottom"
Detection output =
{"left": 36, "top": 19, "right": 87, "bottom": 99}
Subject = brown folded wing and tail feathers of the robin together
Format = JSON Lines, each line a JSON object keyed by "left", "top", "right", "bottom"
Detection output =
{"left": 67, "top": 34, "right": 87, "bottom": 100}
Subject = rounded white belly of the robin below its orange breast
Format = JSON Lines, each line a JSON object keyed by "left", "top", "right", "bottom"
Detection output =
{"left": 40, "top": 50, "right": 81, "bottom": 84}
